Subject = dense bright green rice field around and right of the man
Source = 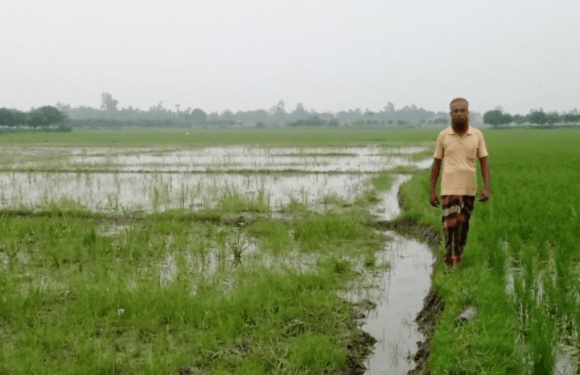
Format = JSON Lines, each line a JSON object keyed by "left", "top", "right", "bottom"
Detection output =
{"left": 401, "top": 130, "right": 580, "bottom": 374}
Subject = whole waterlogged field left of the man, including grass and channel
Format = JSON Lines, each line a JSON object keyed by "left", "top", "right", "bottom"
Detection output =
{"left": 0, "top": 139, "right": 433, "bottom": 374}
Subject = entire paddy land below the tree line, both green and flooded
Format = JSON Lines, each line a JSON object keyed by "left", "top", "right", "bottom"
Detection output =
{"left": 0, "top": 129, "right": 580, "bottom": 375}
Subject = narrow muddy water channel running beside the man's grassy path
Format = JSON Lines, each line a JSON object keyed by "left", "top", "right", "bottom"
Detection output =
{"left": 362, "top": 176, "right": 435, "bottom": 375}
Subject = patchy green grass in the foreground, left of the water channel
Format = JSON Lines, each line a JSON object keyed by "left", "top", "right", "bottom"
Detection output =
{"left": 0, "top": 213, "right": 377, "bottom": 374}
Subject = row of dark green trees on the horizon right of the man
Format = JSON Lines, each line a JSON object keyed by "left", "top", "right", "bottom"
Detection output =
{"left": 483, "top": 108, "right": 580, "bottom": 127}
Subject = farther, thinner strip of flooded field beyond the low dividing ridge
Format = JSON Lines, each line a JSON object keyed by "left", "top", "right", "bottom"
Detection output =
{"left": 2, "top": 146, "right": 425, "bottom": 173}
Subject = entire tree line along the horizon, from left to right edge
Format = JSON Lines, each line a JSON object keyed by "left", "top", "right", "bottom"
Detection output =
{"left": 5, "top": 93, "right": 580, "bottom": 130}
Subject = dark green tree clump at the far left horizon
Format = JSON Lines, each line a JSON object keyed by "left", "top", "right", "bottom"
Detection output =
{"left": 0, "top": 106, "right": 68, "bottom": 130}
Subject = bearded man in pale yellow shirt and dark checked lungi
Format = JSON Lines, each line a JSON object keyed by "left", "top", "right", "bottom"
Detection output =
{"left": 429, "top": 98, "right": 490, "bottom": 268}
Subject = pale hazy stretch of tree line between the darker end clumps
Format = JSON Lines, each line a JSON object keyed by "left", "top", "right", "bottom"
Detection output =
{"left": 51, "top": 93, "right": 483, "bottom": 128}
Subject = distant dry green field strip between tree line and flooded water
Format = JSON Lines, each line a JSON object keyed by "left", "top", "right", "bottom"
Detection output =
{"left": 0, "top": 128, "right": 439, "bottom": 147}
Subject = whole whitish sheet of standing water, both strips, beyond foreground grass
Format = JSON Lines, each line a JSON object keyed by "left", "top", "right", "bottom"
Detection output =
{"left": 0, "top": 146, "right": 431, "bottom": 213}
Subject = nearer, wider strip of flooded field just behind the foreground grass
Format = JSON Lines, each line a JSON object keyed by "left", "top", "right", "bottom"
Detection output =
{"left": 0, "top": 172, "right": 372, "bottom": 212}
